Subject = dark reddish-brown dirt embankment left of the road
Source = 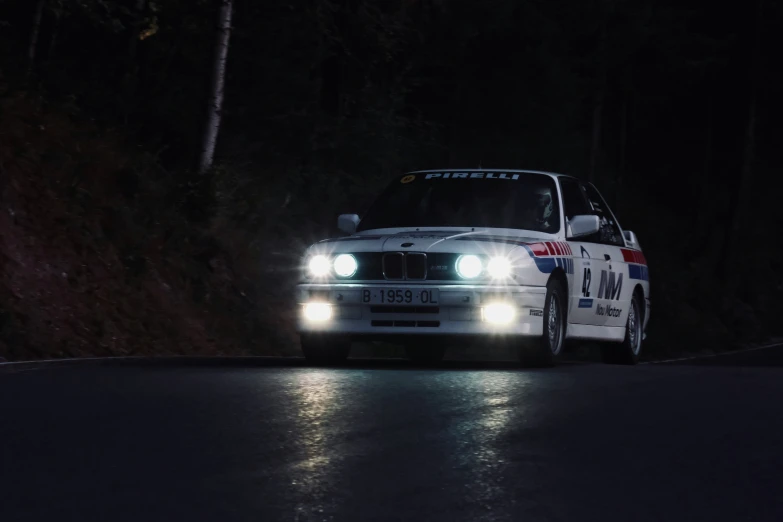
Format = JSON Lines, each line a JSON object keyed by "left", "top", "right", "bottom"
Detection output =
{"left": 0, "top": 94, "right": 298, "bottom": 360}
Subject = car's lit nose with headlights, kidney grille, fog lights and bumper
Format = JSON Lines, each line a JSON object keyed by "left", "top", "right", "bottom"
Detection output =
{"left": 297, "top": 244, "right": 546, "bottom": 338}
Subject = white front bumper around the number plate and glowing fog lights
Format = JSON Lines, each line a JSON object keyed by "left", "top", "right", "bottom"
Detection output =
{"left": 297, "top": 283, "right": 546, "bottom": 337}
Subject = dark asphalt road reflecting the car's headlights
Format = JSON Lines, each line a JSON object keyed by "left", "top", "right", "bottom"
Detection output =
{"left": 0, "top": 348, "right": 783, "bottom": 522}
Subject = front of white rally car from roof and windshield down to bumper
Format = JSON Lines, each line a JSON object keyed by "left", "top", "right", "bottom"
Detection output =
{"left": 297, "top": 171, "right": 565, "bottom": 359}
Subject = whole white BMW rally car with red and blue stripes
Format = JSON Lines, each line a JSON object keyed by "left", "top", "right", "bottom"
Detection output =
{"left": 297, "top": 170, "right": 650, "bottom": 366}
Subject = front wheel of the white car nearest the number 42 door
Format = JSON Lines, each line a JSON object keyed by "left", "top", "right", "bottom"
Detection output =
{"left": 517, "top": 279, "right": 567, "bottom": 368}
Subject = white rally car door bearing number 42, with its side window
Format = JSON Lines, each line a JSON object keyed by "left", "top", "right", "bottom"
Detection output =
{"left": 558, "top": 177, "right": 608, "bottom": 325}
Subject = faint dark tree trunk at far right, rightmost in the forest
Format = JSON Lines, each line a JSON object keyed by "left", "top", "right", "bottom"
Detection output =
{"left": 724, "top": 0, "right": 764, "bottom": 298}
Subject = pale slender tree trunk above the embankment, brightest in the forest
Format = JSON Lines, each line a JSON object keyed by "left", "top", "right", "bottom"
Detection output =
{"left": 198, "top": 0, "right": 233, "bottom": 174}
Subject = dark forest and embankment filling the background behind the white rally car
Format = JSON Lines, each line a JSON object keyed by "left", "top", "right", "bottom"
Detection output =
{"left": 0, "top": 0, "right": 783, "bottom": 359}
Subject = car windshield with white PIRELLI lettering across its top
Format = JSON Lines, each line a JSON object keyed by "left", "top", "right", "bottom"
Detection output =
{"left": 358, "top": 171, "right": 560, "bottom": 234}
